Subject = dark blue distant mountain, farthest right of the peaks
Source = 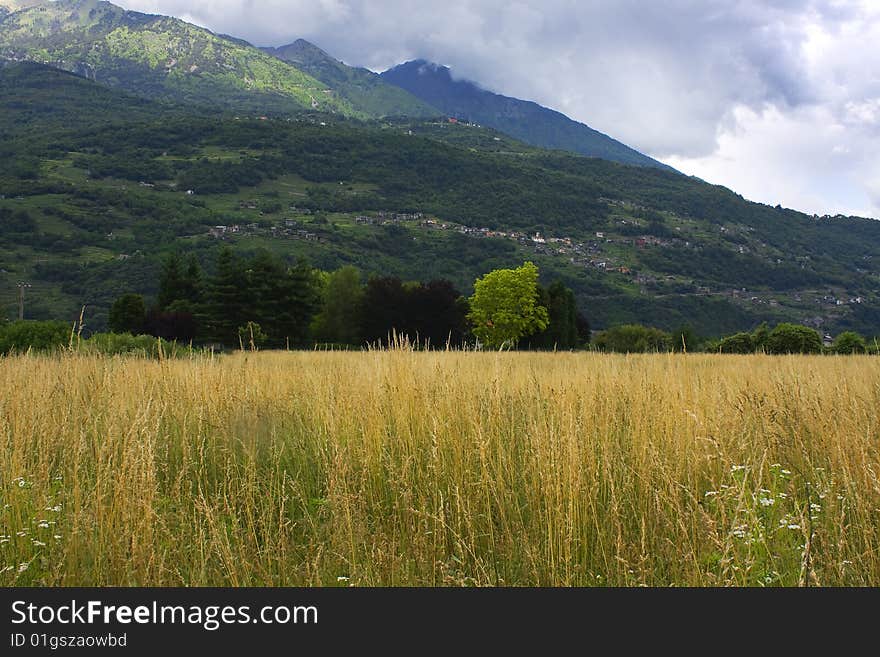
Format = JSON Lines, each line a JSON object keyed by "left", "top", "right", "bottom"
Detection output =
{"left": 381, "top": 59, "right": 671, "bottom": 170}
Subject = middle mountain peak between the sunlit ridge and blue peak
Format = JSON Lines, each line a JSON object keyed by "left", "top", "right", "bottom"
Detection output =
{"left": 263, "top": 39, "right": 442, "bottom": 117}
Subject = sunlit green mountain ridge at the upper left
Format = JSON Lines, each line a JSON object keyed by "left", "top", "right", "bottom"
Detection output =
{"left": 0, "top": 0, "right": 360, "bottom": 118}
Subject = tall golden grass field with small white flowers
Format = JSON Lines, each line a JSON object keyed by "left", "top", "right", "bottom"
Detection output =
{"left": 0, "top": 349, "right": 880, "bottom": 586}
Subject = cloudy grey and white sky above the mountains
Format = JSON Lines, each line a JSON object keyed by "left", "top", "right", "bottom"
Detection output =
{"left": 117, "top": 0, "right": 880, "bottom": 218}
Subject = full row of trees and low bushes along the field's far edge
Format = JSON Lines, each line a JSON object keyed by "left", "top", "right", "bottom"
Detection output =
{"left": 0, "top": 247, "right": 880, "bottom": 354}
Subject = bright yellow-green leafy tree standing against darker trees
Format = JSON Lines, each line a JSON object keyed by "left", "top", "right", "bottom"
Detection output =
{"left": 468, "top": 262, "right": 549, "bottom": 349}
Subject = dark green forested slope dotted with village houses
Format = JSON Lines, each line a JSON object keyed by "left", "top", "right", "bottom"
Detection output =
{"left": 0, "top": 65, "right": 880, "bottom": 335}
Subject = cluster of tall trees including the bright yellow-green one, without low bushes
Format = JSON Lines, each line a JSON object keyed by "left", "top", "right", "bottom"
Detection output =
{"left": 103, "top": 247, "right": 590, "bottom": 349}
